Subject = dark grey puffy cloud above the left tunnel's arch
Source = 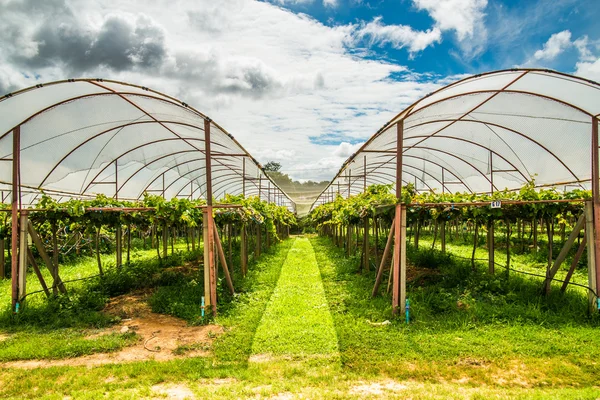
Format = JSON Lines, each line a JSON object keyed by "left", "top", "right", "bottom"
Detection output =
{"left": 3, "top": 1, "right": 166, "bottom": 73}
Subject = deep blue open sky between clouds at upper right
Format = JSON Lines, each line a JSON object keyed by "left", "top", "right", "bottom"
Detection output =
{"left": 271, "top": 0, "right": 600, "bottom": 76}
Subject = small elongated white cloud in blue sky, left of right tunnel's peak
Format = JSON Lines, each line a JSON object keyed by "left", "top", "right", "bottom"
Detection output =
{"left": 354, "top": 17, "right": 442, "bottom": 54}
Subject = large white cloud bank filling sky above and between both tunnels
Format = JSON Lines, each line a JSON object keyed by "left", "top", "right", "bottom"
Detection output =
{"left": 0, "top": 0, "right": 439, "bottom": 180}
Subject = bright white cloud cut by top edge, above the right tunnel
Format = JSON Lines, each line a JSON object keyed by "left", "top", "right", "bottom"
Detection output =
{"left": 413, "top": 0, "right": 488, "bottom": 42}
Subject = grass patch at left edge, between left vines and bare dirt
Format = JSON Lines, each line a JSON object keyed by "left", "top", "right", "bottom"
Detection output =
{"left": 0, "top": 329, "right": 139, "bottom": 362}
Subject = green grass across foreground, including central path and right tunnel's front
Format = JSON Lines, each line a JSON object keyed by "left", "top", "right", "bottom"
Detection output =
{"left": 0, "top": 237, "right": 600, "bottom": 399}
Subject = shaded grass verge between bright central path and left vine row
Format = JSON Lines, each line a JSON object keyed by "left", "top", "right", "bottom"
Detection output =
{"left": 213, "top": 239, "right": 294, "bottom": 365}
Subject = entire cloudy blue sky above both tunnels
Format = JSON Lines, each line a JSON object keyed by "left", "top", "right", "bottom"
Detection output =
{"left": 0, "top": 0, "right": 600, "bottom": 180}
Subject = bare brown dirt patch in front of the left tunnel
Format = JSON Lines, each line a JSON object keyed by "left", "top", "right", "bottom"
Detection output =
{"left": 2, "top": 291, "right": 223, "bottom": 369}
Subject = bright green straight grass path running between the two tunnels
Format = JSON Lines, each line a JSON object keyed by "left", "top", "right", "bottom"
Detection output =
{"left": 252, "top": 238, "right": 338, "bottom": 356}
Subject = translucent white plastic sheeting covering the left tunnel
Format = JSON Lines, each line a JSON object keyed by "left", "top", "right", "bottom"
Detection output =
{"left": 0, "top": 79, "right": 295, "bottom": 211}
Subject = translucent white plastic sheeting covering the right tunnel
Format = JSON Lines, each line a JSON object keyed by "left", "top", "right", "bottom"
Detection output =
{"left": 315, "top": 69, "right": 600, "bottom": 205}
